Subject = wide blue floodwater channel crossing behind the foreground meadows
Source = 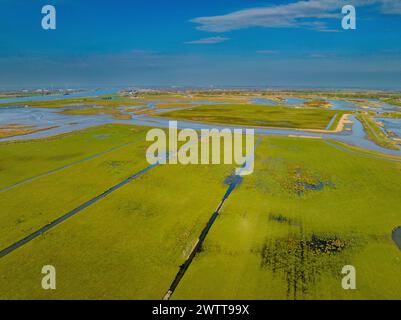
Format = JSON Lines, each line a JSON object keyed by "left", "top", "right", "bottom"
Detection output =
{"left": 0, "top": 103, "right": 401, "bottom": 155}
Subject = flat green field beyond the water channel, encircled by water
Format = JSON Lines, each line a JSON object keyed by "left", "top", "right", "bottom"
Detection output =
{"left": 160, "top": 104, "right": 345, "bottom": 130}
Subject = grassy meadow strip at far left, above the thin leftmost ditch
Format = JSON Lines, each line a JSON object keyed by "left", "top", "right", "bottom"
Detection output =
{"left": 0, "top": 125, "right": 144, "bottom": 189}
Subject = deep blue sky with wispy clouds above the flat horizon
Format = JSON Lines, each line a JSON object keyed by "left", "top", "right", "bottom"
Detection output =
{"left": 0, "top": 0, "right": 401, "bottom": 89}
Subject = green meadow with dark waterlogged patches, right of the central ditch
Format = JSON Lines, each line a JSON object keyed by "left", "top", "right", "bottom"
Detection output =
{"left": 174, "top": 138, "right": 401, "bottom": 299}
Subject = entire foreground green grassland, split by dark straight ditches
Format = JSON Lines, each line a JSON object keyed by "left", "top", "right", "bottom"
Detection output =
{"left": 0, "top": 125, "right": 401, "bottom": 299}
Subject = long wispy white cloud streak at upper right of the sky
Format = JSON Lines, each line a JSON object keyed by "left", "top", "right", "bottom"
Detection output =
{"left": 191, "top": 0, "right": 401, "bottom": 32}
